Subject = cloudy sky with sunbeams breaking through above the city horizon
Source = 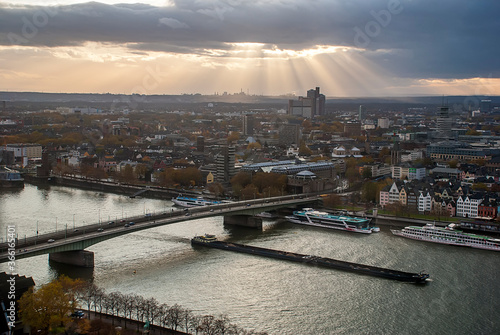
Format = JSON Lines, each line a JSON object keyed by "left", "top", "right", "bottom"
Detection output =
{"left": 0, "top": 0, "right": 500, "bottom": 97}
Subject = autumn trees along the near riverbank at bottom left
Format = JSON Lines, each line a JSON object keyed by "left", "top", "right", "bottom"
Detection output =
{"left": 19, "top": 276, "right": 267, "bottom": 335}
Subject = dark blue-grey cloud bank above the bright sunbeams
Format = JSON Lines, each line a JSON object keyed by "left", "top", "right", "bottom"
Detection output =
{"left": 0, "top": 0, "right": 500, "bottom": 78}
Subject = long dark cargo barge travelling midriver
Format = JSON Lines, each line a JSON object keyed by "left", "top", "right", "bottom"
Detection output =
{"left": 191, "top": 235, "right": 429, "bottom": 283}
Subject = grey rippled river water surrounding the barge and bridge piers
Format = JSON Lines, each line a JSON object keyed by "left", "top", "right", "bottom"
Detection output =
{"left": 0, "top": 184, "right": 500, "bottom": 335}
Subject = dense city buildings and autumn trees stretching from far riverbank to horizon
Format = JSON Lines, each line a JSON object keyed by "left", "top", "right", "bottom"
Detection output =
{"left": 0, "top": 91, "right": 500, "bottom": 219}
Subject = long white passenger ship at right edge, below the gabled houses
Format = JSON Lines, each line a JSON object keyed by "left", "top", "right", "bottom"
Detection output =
{"left": 391, "top": 223, "right": 500, "bottom": 250}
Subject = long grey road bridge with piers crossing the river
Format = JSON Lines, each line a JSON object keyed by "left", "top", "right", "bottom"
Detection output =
{"left": 0, "top": 195, "right": 319, "bottom": 267}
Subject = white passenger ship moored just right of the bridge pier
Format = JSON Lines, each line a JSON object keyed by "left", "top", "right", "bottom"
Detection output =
{"left": 285, "top": 208, "right": 380, "bottom": 234}
